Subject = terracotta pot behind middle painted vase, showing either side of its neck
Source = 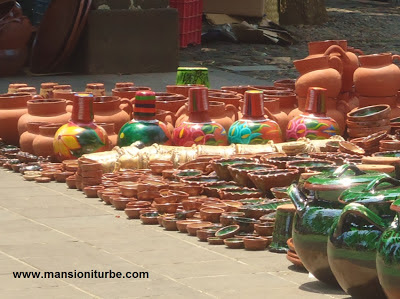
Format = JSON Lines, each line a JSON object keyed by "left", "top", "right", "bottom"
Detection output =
{"left": 175, "top": 101, "right": 239, "bottom": 132}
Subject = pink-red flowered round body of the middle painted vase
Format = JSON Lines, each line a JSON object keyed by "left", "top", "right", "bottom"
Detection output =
{"left": 172, "top": 122, "right": 228, "bottom": 146}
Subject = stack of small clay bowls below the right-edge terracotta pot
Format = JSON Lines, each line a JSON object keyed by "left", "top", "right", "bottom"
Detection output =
{"left": 346, "top": 105, "right": 391, "bottom": 138}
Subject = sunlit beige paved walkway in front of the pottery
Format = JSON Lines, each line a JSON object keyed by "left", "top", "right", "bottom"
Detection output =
{"left": 0, "top": 169, "right": 348, "bottom": 298}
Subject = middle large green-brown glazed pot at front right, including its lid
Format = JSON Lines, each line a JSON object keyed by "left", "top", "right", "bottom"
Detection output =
{"left": 327, "top": 176, "right": 400, "bottom": 298}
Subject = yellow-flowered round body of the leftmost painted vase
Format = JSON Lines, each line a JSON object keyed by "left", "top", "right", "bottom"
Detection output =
{"left": 53, "top": 123, "right": 108, "bottom": 160}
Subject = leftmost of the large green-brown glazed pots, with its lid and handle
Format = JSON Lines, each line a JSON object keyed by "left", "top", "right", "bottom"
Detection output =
{"left": 288, "top": 164, "right": 388, "bottom": 285}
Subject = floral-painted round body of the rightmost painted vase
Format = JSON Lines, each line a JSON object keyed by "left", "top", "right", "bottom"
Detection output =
{"left": 286, "top": 116, "right": 340, "bottom": 141}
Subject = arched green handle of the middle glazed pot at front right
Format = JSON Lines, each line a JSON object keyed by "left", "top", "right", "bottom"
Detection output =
{"left": 332, "top": 202, "right": 386, "bottom": 238}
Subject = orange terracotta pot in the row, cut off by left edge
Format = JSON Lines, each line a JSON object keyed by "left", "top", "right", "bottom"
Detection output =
{"left": 0, "top": 93, "right": 32, "bottom": 145}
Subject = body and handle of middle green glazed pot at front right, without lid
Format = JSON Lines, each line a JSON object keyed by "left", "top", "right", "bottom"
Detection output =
{"left": 327, "top": 203, "right": 393, "bottom": 299}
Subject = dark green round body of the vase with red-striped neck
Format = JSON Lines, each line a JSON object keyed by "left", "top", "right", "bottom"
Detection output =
{"left": 118, "top": 120, "right": 171, "bottom": 146}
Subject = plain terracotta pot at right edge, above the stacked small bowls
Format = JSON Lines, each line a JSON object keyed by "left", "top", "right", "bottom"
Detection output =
{"left": 354, "top": 53, "right": 400, "bottom": 97}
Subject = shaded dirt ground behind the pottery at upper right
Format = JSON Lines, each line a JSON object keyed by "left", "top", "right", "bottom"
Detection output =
{"left": 180, "top": 0, "right": 400, "bottom": 81}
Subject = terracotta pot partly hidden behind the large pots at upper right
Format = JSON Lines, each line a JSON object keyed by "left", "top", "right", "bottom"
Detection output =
{"left": 307, "top": 40, "right": 362, "bottom": 92}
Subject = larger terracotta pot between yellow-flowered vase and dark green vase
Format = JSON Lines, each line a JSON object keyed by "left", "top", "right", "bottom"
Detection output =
{"left": 93, "top": 96, "right": 133, "bottom": 131}
